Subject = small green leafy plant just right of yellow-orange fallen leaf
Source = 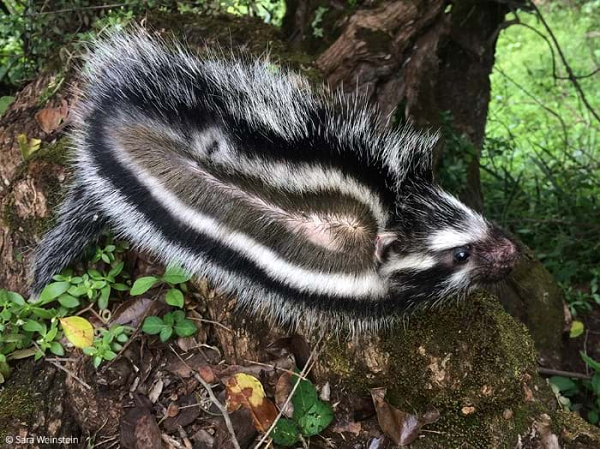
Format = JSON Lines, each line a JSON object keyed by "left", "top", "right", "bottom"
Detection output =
{"left": 271, "top": 376, "right": 333, "bottom": 446}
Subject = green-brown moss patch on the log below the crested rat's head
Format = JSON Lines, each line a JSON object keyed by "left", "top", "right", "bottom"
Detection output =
{"left": 325, "top": 293, "right": 536, "bottom": 447}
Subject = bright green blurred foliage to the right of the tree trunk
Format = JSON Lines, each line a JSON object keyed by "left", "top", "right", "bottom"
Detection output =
{"left": 481, "top": 0, "right": 600, "bottom": 312}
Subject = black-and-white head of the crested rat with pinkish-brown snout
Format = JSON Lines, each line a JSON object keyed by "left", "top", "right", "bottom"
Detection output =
{"left": 376, "top": 138, "right": 519, "bottom": 304}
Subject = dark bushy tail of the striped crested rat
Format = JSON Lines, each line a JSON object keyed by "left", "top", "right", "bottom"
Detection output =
{"left": 30, "top": 185, "right": 106, "bottom": 297}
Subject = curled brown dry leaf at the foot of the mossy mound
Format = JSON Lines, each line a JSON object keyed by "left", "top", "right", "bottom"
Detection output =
{"left": 371, "top": 388, "right": 439, "bottom": 446}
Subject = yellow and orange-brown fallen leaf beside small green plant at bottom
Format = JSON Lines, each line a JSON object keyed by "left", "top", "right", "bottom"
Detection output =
{"left": 225, "top": 373, "right": 277, "bottom": 432}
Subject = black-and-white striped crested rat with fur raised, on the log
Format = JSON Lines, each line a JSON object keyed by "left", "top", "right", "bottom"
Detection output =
{"left": 31, "top": 32, "right": 518, "bottom": 329}
